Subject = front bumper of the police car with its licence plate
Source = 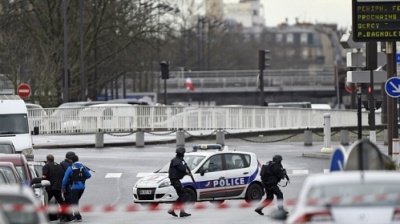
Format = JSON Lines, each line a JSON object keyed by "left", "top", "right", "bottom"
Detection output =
{"left": 133, "top": 186, "right": 178, "bottom": 203}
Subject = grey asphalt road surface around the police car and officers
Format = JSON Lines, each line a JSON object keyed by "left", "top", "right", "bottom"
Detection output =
{"left": 34, "top": 140, "right": 334, "bottom": 224}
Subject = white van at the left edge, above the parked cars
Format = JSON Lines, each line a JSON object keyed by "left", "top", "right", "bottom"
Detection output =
{"left": 0, "top": 95, "right": 33, "bottom": 160}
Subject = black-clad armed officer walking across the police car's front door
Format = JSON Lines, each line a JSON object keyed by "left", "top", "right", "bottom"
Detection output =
{"left": 168, "top": 147, "right": 191, "bottom": 217}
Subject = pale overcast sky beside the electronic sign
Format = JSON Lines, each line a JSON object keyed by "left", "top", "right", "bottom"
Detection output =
{"left": 224, "top": 0, "right": 352, "bottom": 29}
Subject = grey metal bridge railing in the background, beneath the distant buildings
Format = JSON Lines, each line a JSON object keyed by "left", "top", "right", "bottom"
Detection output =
{"left": 167, "top": 69, "right": 335, "bottom": 92}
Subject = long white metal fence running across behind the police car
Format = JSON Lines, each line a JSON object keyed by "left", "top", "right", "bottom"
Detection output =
{"left": 29, "top": 106, "right": 380, "bottom": 134}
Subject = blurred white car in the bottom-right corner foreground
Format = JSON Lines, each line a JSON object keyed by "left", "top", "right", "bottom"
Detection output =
{"left": 286, "top": 170, "right": 400, "bottom": 224}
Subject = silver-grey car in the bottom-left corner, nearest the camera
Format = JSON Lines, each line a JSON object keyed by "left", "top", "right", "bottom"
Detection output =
{"left": 0, "top": 183, "right": 49, "bottom": 224}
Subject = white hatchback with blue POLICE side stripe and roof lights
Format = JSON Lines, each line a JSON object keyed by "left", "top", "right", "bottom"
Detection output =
{"left": 133, "top": 144, "right": 264, "bottom": 204}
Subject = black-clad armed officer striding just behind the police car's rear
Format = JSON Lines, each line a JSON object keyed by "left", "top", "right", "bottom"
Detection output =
{"left": 254, "top": 155, "right": 290, "bottom": 215}
